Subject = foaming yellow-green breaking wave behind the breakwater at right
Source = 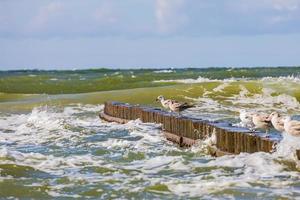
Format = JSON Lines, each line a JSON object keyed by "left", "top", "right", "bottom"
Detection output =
{"left": 177, "top": 77, "right": 300, "bottom": 123}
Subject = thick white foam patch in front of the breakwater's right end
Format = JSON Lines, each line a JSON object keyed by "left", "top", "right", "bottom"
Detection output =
{"left": 167, "top": 153, "right": 298, "bottom": 196}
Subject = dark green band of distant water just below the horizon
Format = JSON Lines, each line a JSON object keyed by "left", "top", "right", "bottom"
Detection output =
{"left": 0, "top": 67, "right": 300, "bottom": 94}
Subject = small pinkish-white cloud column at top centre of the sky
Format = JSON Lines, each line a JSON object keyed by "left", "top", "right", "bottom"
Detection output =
{"left": 155, "top": 0, "right": 187, "bottom": 33}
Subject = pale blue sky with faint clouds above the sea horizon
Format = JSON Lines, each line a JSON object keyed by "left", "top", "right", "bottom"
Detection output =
{"left": 0, "top": 0, "right": 300, "bottom": 70}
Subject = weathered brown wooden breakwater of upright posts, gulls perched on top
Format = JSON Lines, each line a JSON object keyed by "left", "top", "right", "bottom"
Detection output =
{"left": 100, "top": 102, "right": 286, "bottom": 157}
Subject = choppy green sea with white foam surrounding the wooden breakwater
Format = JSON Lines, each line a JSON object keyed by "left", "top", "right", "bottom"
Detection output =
{"left": 0, "top": 68, "right": 300, "bottom": 199}
